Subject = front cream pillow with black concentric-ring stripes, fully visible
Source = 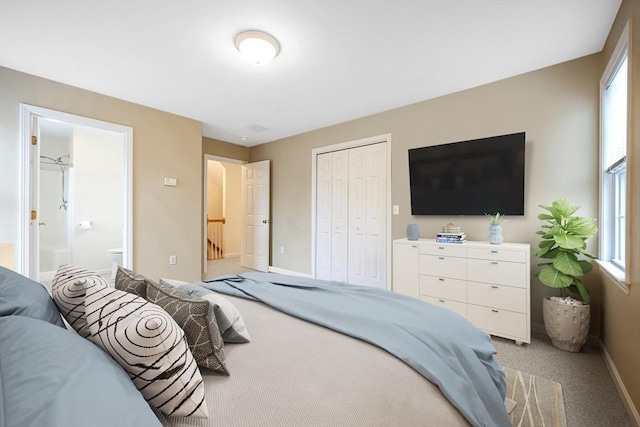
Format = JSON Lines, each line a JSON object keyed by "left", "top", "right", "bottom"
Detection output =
{"left": 85, "top": 287, "right": 209, "bottom": 418}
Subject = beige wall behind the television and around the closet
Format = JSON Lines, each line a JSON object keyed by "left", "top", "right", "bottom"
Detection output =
{"left": 251, "top": 54, "right": 602, "bottom": 334}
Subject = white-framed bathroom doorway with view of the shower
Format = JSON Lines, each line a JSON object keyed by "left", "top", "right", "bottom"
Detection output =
{"left": 22, "top": 105, "right": 132, "bottom": 283}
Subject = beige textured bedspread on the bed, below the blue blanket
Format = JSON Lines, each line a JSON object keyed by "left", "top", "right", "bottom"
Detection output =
{"left": 156, "top": 296, "right": 469, "bottom": 427}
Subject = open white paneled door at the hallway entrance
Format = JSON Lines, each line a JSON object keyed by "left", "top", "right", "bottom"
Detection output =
{"left": 240, "top": 160, "right": 271, "bottom": 272}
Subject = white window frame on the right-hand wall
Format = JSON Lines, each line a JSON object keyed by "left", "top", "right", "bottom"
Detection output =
{"left": 598, "top": 24, "right": 631, "bottom": 294}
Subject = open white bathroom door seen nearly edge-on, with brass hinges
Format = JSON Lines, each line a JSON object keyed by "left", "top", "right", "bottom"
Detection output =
{"left": 28, "top": 116, "right": 40, "bottom": 280}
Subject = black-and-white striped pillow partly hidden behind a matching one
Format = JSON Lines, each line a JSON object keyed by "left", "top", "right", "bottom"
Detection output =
{"left": 51, "top": 265, "right": 109, "bottom": 338}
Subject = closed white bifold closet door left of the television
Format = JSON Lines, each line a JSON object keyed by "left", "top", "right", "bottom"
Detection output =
{"left": 316, "top": 143, "right": 387, "bottom": 288}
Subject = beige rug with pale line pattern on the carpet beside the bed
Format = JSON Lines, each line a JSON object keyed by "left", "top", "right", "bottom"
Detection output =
{"left": 502, "top": 366, "right": 567, "bottom": 427}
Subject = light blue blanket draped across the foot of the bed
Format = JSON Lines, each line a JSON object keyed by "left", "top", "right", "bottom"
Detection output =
{"left": 198, "top": 273, "right": 511, "bottom": 427}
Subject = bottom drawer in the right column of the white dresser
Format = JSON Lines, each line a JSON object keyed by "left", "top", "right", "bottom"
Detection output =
{"left": 467, "top": 304, "right": 527, "bottom": 341}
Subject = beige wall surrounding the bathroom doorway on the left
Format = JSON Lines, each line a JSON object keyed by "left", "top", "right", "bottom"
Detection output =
{"left": 0, "top": 67, "right": 203, "bottom": 281}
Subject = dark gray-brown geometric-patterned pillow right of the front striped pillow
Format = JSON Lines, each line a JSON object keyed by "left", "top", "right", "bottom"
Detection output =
{"left": 147, "top": 280, "right": 229, "bottom": 375}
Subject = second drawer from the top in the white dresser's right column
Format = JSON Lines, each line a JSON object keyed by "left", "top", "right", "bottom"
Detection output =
{"left": 464, "top": 259, "right": 529, "bottom": 288}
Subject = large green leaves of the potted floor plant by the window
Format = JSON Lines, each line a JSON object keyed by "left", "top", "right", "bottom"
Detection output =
{"left": 535, "top": 199, "right": 598, "bottom": 303}
